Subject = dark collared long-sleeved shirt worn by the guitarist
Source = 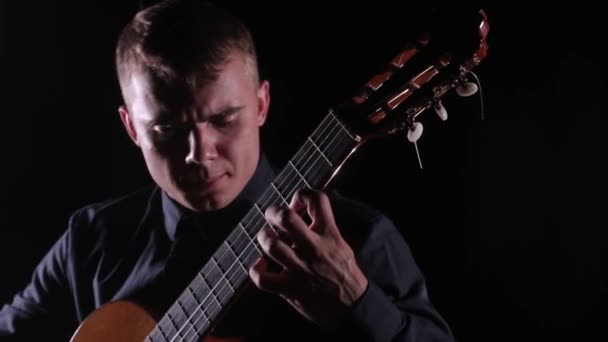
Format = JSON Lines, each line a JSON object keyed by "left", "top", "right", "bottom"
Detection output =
{"left": 0, "top": 158, "right": 453, "bottom": 341}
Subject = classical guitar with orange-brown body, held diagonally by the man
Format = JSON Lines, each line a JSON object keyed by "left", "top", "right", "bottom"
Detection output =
{"left": 72, "top": 11, "right": 489, "bottom": 342}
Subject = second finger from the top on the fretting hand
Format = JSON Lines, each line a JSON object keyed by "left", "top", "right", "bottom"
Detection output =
{"left": 265, "top": 206, "right": 317, "bottom": 250}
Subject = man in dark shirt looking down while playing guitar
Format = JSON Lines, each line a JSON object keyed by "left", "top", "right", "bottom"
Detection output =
{"left": 0, "top": 0, "right": 452, "bottom": 341}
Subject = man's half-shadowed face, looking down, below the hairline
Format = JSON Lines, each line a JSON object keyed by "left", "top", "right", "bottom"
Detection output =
{"left": 120, "top": 55, "right": 270, "bottom": 211}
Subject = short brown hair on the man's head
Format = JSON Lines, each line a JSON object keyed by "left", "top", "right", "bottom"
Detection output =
{"left": 115, "top": 0, "right": 259, "bottom": 99}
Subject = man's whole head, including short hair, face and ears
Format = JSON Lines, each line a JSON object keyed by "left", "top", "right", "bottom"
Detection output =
{"left": 116, "top": 0, "right": 270, "bottom": 211}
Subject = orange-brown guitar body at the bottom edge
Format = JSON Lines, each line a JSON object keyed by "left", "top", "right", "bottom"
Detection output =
{"left": 70, "top": 301, "right": 245, "bottom": 342}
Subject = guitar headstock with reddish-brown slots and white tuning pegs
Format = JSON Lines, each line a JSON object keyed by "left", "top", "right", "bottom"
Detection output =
{"left": 335, "top": 10, "right": 490, "bottom": 148}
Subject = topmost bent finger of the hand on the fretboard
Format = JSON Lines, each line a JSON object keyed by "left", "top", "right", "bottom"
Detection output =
{"left": 290, "top": 189, "right": 337, "bottom": 233}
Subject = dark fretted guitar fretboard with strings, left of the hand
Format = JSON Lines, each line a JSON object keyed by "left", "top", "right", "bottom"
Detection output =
{"left": 146, "top": 112, "right": 357, "bottom": 341}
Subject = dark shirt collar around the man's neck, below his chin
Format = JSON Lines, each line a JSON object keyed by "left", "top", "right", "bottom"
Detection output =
{"left": 161, "top": 154, "right": 275, "bottom": 241}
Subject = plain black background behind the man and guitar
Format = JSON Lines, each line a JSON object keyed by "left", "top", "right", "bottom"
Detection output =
{"left": 0, "top": 0, "right": 608, "bottom": 341}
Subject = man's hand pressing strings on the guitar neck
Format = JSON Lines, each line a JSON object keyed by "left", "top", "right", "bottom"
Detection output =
{"left": 250, "top": 190, "right": 367, "bottom": 326}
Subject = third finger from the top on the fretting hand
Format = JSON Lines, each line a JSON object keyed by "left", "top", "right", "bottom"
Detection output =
{"left": 257, "top": 227, "right": 310, "bottom": 273}
